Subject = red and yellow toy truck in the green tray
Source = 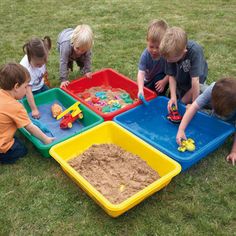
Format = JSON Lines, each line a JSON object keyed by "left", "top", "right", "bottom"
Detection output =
{"left": 57, "top": 102, "right": 84, "bottom": 129}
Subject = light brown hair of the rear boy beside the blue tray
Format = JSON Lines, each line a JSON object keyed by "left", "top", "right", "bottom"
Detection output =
{"left": 147, "top": 19, "right": 168, "bottom": 44}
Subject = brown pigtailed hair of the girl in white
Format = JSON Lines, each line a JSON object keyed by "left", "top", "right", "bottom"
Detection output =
{"left": 23, "top": 36, "right": 52, "bottom": 62}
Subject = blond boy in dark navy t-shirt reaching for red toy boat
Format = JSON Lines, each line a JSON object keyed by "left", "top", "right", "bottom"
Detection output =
{"left": 160, "top": 27, "right": 208, "bottom": 111}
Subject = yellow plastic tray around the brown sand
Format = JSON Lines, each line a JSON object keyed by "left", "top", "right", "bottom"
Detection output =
{"left": 50, "top": 121, "right": 181, "bottom": 217}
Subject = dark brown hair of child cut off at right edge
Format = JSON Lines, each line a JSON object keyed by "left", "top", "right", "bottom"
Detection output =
{"left": 211, "top": 78, "right": 236, "bottom": 117}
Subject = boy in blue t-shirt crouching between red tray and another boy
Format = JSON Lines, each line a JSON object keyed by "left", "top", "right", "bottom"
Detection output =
{"left": 137, "top": 20, "right": 168, "bottom": 97}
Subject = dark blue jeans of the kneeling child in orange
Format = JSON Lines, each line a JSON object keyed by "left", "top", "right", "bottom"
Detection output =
{"left": 0, "top": 137, "right": 28, "bottom": 164}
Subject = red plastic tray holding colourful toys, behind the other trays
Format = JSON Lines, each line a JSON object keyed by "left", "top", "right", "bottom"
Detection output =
{"left": 63, "top": 68, "right": 156, "bottom": 121}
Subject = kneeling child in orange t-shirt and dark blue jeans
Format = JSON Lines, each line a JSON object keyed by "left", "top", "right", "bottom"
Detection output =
{"left": 0, "top": 63, "right": 54, "bottom": 164}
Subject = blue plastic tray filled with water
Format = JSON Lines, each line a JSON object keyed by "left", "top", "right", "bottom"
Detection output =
{"left": 114, "top": 97, "right": 235, "bottom": 170}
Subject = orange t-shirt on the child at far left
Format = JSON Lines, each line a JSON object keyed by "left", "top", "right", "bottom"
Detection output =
{"left": 0, "top": 89, "right": 31, "bottom": 153}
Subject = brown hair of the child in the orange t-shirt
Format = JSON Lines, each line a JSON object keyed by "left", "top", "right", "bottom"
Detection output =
{"left": 0, "top": 62, "right": 30, "bottom": 90}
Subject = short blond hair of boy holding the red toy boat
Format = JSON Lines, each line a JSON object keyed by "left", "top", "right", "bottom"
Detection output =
{"left": 160, "top": 27, "right": 188, "bottom": 59}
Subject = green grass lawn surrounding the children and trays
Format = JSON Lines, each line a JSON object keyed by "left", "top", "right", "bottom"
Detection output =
{"left": 0, "top": 0, "right": 236, "bottom": 236}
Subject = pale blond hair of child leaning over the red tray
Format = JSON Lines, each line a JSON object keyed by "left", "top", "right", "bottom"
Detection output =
{"left": 71, "top": 24, "right": 93, "bottom": 50}
